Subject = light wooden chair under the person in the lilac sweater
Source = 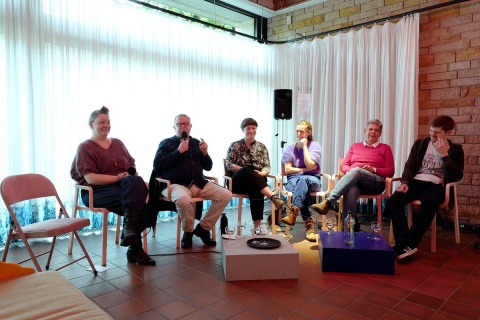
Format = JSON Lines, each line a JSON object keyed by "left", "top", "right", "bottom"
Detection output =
{"left": 279, "top": 162, "right": 334, "bottom": 235}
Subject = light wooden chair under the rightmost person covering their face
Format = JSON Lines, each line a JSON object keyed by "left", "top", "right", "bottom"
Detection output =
{"left": 388, "top": 178, "right": 460, "bottom": 253}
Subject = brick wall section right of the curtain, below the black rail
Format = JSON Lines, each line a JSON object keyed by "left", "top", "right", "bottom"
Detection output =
{"left": 419, "top": 0, "right": 480, "bottom": 224}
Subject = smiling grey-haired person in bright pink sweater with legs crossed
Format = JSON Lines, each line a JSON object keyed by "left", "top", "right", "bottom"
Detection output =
{"left": 311, "top": 119, "right": 395, "bottom": 231}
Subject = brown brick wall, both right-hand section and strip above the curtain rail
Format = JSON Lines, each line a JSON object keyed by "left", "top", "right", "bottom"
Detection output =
{"left": 268, "top": 0, "right": 480, "bottom": 225}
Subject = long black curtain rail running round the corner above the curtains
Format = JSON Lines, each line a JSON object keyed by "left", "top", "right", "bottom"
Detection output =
{"left": 128, "top": 0, "right": 471, "bottom": 44}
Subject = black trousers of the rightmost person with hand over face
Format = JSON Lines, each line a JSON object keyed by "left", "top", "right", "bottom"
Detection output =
{"left": 385, "top": 180, "right": 445, "bottom": 248}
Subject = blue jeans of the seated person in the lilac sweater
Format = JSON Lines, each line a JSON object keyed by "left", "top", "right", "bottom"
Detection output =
{"left": 285, "top": 174, "right": 322, "bottom": 221}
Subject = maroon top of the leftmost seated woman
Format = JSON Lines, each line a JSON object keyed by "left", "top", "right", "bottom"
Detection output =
{"left": 70, "top": 138, "right": 135, "bottom": 185}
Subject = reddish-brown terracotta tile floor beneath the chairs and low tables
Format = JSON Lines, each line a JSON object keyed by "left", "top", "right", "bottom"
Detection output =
{"left": 2, "top": 206, "right": 480, "bottom": 320}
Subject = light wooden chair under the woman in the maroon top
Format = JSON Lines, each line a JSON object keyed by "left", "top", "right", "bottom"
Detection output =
{"left": 68, "top": 184, "right": 148, "bottom": 267}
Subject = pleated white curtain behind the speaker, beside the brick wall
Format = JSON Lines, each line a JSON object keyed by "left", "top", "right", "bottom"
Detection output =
{"left": 274, "top": 14, "right": 419, "bottom": 180}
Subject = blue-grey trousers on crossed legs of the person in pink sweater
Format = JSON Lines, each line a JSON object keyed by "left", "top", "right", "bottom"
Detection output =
{"left": 327, "top": 167, "right": 385, "bottom": 217}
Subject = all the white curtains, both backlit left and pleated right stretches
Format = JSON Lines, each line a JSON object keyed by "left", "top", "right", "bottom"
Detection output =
{"left": 0, "top": 0, "right": 418, "bottom": 243}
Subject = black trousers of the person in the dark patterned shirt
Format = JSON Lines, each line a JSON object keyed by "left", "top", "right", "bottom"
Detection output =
{"left": 232, "top": 167, "right": 268, "bottom": 220}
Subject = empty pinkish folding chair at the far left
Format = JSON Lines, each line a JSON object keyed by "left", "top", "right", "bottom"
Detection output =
{"left": 1, "top": 173, "right": 97, "bottom": 274}
